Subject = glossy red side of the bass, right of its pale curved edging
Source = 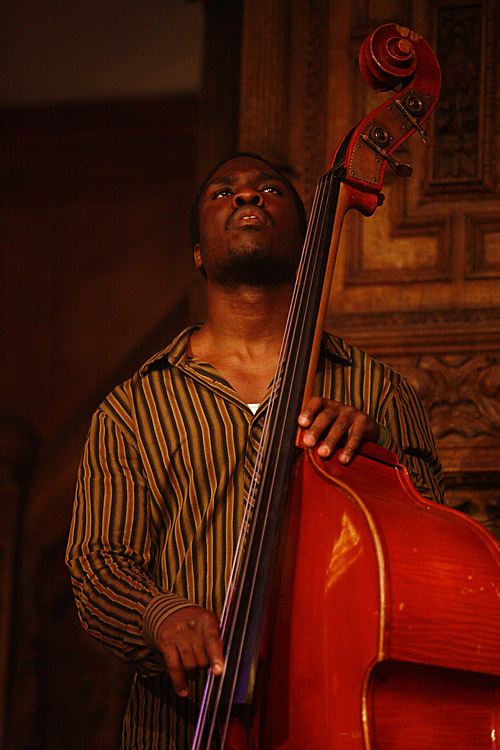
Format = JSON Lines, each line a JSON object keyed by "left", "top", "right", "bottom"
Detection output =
{"left": 312, "top": 449, "right": 500, "bottom": 675}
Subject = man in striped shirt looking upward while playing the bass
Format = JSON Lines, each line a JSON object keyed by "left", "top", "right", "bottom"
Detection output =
{"left": 67, "top": 155, "right": 441, "bottom": 750}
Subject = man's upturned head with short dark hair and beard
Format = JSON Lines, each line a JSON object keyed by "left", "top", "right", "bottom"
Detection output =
{"left": 195, "top": 156, "right": 302, "bottom": 285}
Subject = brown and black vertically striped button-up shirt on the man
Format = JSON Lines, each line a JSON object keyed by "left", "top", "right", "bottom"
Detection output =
{"left": 67, "top": 328, "right": 442, "bottom": 750}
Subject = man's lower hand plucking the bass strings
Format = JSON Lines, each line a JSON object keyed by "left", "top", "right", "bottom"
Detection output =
{"left": 156, "top": 606, "right": 224, "bottom": 698}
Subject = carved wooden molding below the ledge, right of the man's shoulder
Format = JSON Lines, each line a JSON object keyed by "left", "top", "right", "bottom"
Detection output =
{"left": 333, "top": 309, "right": 500, "bottom": 484}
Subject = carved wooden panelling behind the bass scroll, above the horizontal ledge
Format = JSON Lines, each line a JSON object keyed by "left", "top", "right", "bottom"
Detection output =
{"left": 324, "top": 0, "right": 500, "bottom": 315}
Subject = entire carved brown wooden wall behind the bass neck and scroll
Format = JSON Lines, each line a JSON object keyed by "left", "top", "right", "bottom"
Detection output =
{"left": 240, "top": 0, "right": 500, "bottom": 537}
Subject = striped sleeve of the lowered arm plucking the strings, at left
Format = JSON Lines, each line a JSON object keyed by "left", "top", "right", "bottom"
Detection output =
{"left": 66, "top": 410, "right": 197, "bottom": 673}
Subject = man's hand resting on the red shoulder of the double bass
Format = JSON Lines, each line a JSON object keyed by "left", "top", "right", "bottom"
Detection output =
{"left": 299, "top": 396, "right": 380, "bottom": 464}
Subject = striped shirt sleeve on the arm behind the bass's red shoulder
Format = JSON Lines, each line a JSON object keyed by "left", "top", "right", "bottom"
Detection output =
{"left": 379, "top": 378, "right": 444, "bottom": 504}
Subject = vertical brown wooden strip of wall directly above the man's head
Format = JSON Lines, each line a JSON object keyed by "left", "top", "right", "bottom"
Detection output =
{"left": 239, "top": 0, "right": 329, "bottom": 206}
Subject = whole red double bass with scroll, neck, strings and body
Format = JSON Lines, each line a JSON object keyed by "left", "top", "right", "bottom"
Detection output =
{"left": 193, "top": 24, "right": 500, "bottom": 750}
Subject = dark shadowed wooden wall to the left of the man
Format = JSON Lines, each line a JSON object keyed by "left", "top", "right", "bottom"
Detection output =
{"left": 0, "top": 96, "right": 198, "bottom": 750}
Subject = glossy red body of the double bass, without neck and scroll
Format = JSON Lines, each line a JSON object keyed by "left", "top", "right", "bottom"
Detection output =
{"left": 258, "top": 444, "right": 500, "bottom": 750}
